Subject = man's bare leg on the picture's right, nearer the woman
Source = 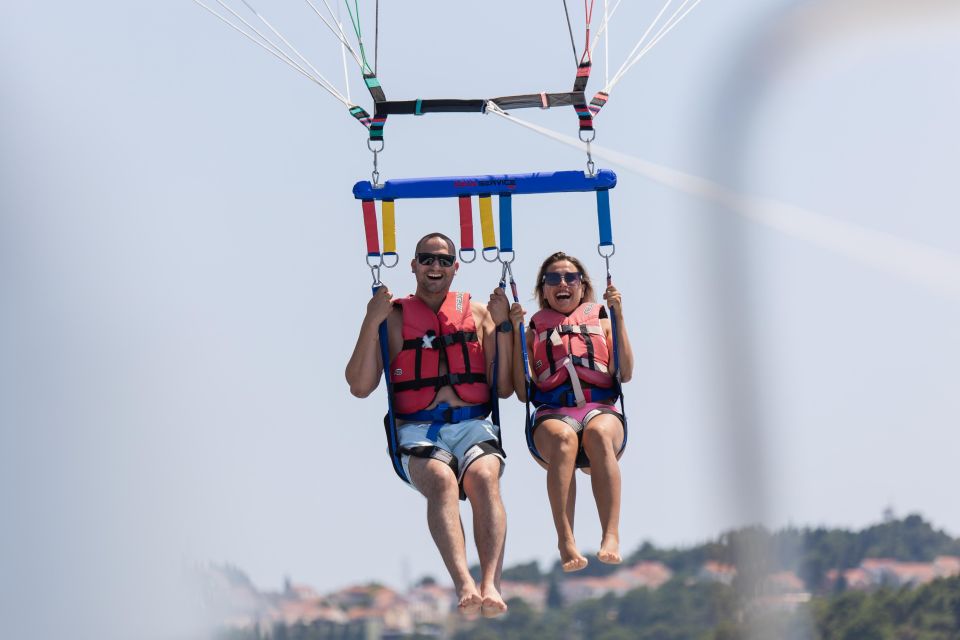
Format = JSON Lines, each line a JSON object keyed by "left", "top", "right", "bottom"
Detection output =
{"left": 463, "top": 455, "right": 507, "bottom": 618}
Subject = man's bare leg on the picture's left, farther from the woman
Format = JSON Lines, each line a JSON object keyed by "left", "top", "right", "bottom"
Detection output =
{"left": 409, "top": 458, "right": 483, "bottom": 613}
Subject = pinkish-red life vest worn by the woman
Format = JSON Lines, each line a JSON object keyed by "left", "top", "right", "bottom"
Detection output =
{"left": 530, "top": 302, "right": 615, "bottom": 406}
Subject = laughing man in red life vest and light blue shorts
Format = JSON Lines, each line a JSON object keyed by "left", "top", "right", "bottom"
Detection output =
{"left": 346, "top": 233, "right": 513, "bottom": 617}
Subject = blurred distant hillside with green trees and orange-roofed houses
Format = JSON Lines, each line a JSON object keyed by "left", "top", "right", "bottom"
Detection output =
{"left": 214, "top": 515, "right": 960, "bottom": 640}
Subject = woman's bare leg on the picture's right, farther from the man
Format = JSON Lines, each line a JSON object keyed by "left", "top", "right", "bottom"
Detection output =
{"left": 583, "top": 413, "right": 623, "bottom": 564}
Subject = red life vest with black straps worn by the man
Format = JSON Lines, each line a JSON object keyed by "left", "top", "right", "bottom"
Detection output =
{"left": 390, "top": 291, "right": 490, "bottom": 414}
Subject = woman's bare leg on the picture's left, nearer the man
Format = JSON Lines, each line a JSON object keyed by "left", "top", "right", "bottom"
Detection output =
{"left": 533, "top": 418, "right": 587, "bottom": 571}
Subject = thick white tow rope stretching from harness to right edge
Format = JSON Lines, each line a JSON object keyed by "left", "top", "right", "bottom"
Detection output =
{"left": 487, "top": 103, "right": 960, "bottom": 297}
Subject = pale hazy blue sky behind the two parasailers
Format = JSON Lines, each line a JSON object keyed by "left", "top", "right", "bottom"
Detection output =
{"left": 0, "top": 0, "right": 960, "bottom": 638}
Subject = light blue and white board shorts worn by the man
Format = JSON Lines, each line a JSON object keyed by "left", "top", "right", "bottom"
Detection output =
{"left": 397, "top": 419, "right": 506, "bottom": 488}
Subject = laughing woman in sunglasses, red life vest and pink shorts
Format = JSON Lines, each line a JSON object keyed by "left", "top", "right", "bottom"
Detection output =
{"left": 510, "top": 252, "right": 633, "bottom": 571}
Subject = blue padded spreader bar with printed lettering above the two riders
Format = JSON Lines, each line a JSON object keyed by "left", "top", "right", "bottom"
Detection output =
{"left": 353, "top": 169, "right": 617, "bottom": 200}
